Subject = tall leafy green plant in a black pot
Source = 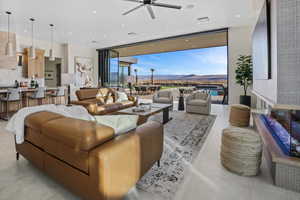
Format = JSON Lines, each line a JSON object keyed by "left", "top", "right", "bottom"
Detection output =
{"left": 235, "top": 55, "right": 253, "bottom": 107}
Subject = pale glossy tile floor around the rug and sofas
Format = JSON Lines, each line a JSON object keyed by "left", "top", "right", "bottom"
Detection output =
{"left": 0, "top": 105, "right": 300, "bottom": 200}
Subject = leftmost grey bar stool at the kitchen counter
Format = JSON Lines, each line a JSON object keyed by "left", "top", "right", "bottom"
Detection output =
{"left": 0, "top": 88, "right": 22, "bottom": 121}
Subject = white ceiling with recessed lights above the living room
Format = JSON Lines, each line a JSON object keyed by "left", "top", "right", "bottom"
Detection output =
{"left": 0, "top": 0, "right": 262, "bottom": 48}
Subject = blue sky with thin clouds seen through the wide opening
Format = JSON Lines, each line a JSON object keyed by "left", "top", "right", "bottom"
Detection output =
{"left": 132, "top": 46, "right": 227, "bottom": 75}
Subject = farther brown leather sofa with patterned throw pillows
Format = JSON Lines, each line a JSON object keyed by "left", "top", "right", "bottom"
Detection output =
{"left": 71, "top": 88, "right": 137, "bottom": 115}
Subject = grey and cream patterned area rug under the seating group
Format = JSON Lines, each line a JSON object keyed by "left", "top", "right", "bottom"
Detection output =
{"left": 137, "top": 111, "right": 216, "bottom": 200}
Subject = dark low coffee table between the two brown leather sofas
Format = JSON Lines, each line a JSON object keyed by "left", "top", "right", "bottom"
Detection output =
{"left": 117, "top": 103, "right": 172, "bottom": 125}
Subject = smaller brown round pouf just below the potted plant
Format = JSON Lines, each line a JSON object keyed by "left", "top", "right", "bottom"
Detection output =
{"left": 229, "top": 104, "right": 250, "bottom": 127}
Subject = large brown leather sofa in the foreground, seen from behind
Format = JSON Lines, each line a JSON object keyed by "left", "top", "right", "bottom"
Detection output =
{"left": 16, "top": 112, "right": 163, "bottom": 200}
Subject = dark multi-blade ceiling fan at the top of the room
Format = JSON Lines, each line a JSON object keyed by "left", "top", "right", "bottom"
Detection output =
{"left": 123, "top": 0, "right": 182, "bottom": 19}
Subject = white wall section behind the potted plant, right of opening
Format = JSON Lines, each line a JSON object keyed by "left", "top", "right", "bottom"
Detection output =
{"left": 228, "top": 26, "right": 256, "bottom": 106}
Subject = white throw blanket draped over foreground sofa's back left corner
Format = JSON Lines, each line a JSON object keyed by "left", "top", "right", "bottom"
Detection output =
{"left": 6, "top": 104, "right": 94, "bottom": 144}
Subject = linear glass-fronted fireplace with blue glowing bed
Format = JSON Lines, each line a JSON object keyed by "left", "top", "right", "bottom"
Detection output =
{"left": 260, "top": 109, "right": 300, "bottom": 157}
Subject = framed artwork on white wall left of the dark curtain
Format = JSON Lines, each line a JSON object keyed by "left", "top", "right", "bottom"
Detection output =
{"left": 75, "top": 56, "right": 94, "bottom": 87}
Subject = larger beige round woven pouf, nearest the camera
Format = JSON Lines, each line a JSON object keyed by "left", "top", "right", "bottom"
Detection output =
{"left": 221, "top": 127, "right": 262, "bottom": 176}
